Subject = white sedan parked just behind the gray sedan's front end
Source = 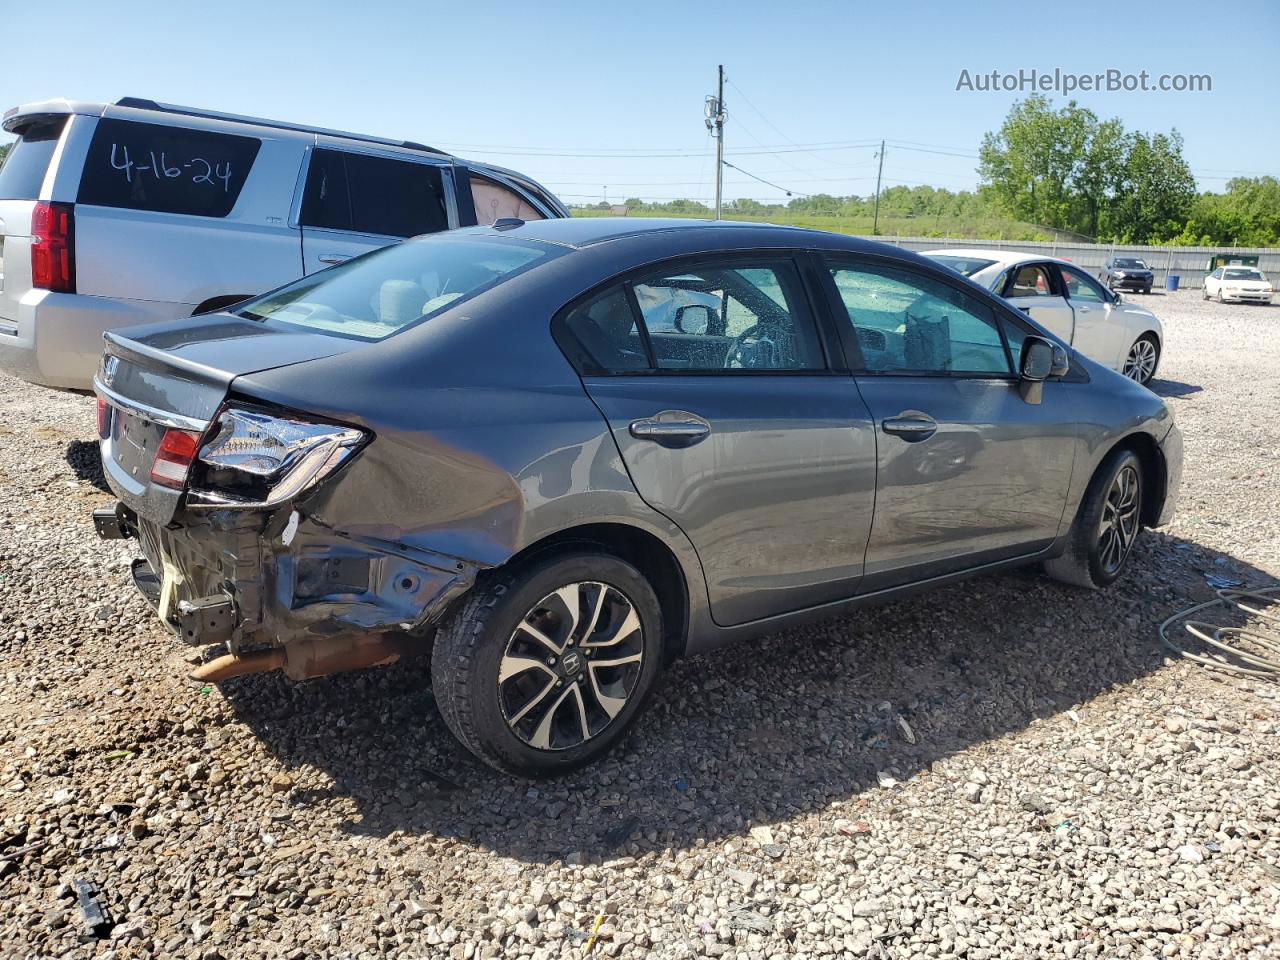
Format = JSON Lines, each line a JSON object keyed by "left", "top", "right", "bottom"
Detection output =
{"left": 922, "top": 248, "right": 1165, "bottom": 384}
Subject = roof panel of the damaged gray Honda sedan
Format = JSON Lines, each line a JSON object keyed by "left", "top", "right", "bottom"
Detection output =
{"left": 465, "top": 216, "right": 910, "bottom": 255}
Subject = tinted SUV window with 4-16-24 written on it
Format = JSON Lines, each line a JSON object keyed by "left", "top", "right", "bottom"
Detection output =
{"left": 77, "top": 119, "right": 262, "bottom": 216}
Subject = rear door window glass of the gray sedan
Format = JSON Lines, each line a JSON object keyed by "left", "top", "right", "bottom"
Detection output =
{"left": 632, "top": 262, "right": 826, "bottom": 372}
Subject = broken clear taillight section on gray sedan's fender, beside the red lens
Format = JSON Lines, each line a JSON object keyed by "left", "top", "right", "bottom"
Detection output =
{"left": 192, "top": 407, "right": 369, "bottom": 507}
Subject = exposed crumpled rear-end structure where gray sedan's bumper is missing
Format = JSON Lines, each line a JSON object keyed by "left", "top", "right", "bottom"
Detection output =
{"left": 93, "top": 507, "right": 479, "bottom": 653}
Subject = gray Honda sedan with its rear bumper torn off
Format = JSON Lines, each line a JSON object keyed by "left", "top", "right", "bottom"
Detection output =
{"left": 95, "top": 219, "right": 1181, "bottom": 776}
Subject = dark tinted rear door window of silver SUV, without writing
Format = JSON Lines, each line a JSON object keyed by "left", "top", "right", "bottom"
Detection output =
{"left": 301, "top": 148, "right": 449, "bottom": 237}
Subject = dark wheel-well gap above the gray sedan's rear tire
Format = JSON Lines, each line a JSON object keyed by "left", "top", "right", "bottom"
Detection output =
{"left": 503, "top": 524, "right": 689, "bottom": 663}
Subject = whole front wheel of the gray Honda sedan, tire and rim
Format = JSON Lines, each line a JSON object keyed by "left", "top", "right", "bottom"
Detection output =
{"left": 1044, "top": 449, "right": 1143, "bottom": 589}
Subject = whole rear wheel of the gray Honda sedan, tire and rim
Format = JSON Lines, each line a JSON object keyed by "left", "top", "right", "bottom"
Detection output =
{"left": 431, "top": 550, "right": 663, "bottom": 777}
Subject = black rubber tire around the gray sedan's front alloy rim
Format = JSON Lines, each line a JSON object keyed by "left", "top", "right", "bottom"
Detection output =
{"left": 1044, "top": 448, "right": 1146, "bottom": 590}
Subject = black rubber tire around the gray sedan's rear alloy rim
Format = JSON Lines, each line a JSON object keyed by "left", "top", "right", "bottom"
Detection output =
{"left": 431, "top": 547, "right": 663, "bottom": 777}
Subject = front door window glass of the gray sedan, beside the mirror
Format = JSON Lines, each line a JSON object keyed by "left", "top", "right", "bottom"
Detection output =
{"left": 831, "top": 265, "right": 1011, "bottom": 374}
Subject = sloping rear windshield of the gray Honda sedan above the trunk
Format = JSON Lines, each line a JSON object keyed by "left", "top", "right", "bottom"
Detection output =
{"left": 236, "top": 233, "right": 563, "bottom": 340}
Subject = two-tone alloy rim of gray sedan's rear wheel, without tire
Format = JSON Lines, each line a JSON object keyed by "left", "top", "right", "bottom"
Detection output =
{"left": 498, "top": 581, "right": 644, "bottom": 750}
